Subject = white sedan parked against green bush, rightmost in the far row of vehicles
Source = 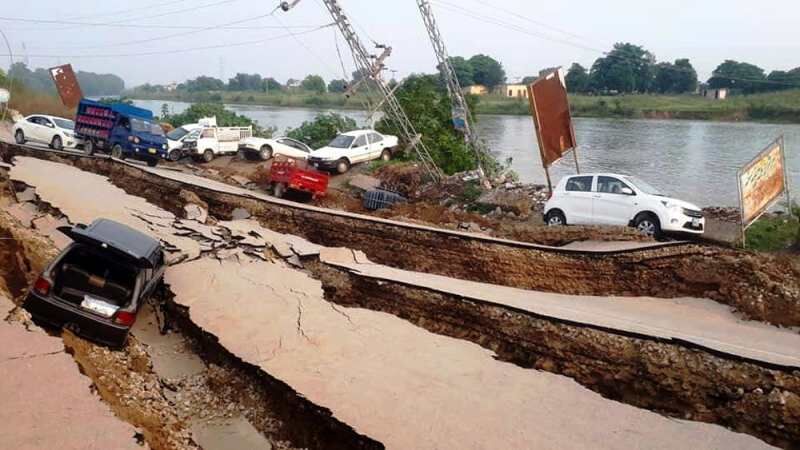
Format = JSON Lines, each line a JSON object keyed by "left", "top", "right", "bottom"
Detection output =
{"left": 308, "top": 130, "right": 398, "bottom": 173}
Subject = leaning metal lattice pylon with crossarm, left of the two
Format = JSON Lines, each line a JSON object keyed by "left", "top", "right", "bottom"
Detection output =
{"left": 281, "top": 0, "right": 444, "bottom": 181}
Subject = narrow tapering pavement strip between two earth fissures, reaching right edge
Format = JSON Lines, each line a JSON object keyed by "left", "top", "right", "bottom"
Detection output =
{"left": 320, "top": 249, "right": 800, "bottom": 368}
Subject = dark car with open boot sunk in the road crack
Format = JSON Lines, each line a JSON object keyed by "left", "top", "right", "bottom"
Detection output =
{"left": 23, "top": 219, "right": 165, "bottom": 347}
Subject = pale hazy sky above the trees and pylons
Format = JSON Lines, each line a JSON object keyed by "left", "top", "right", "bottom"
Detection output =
{"left": 0, "top": 0, "right": 800, "bottom": 87}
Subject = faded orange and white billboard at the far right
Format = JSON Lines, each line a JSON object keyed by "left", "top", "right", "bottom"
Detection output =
{"left": 739, "top": 137, "right": 788, "bottom": 228}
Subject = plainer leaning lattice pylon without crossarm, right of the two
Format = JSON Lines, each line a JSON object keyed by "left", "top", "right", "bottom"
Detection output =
{"left": 417, "top": 0, "right": 488, "bottom": 179}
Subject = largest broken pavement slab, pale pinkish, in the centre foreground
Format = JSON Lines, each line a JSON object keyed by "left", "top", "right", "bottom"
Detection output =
{"left": 166, "top": 258, "right": 767, "bottom": 449}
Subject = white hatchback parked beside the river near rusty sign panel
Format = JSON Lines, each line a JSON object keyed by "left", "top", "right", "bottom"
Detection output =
{"left": 544, "top": 173, "right": 705, "bottom": 236}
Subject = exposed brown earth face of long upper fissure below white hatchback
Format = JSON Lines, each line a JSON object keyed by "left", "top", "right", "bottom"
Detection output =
{"left": 0, "top": 144, "right": 800, "bottom": 326}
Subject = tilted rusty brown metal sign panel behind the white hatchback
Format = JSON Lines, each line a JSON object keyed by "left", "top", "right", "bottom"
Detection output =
{"left": 528, "top": 69, "right": 577, "bottom": 168}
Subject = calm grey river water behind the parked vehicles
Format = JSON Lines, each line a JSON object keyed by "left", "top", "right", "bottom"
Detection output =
{"left": 136, "top": 100, "right": 800, "bottom": 206}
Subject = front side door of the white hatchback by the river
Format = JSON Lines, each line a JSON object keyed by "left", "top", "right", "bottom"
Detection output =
{"left": 592, "top": 176, "right": 638, "bottom": 226}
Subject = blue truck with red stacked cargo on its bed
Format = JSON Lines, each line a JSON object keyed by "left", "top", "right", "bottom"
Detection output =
{"left": 75, "top": 99, "right": 167, "bottom": 167}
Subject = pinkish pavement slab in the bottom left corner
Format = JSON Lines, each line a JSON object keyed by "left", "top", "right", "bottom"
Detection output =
{"left": 0, "top": 321, "right": 143, "bottom": 450}
